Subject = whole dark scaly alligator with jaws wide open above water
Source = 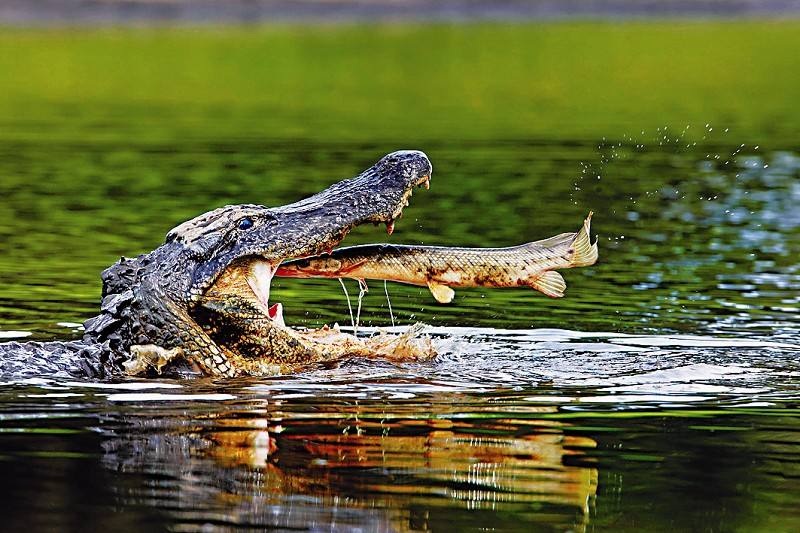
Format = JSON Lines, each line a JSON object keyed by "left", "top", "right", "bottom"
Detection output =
{"left": 0, "top": 150, "right": 432, "bottom": 378}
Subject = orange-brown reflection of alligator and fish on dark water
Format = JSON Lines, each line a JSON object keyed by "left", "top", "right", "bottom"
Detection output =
{"left": 103, "top": 399, "right": 598, "bottom": 531}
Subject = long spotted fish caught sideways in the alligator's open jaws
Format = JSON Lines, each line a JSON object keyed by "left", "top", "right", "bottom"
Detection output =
{"left": 276, "top": 213, "right": 597, "bottom": 303}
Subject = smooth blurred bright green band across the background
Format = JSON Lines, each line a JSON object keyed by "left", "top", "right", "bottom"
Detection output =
{"left": 0, "top": 21, "right": 800, "bottom": 142}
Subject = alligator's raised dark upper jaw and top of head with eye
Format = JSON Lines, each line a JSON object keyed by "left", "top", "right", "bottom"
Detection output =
{"left": 187, "top": 150, "right": 432, "bottom": 303}
